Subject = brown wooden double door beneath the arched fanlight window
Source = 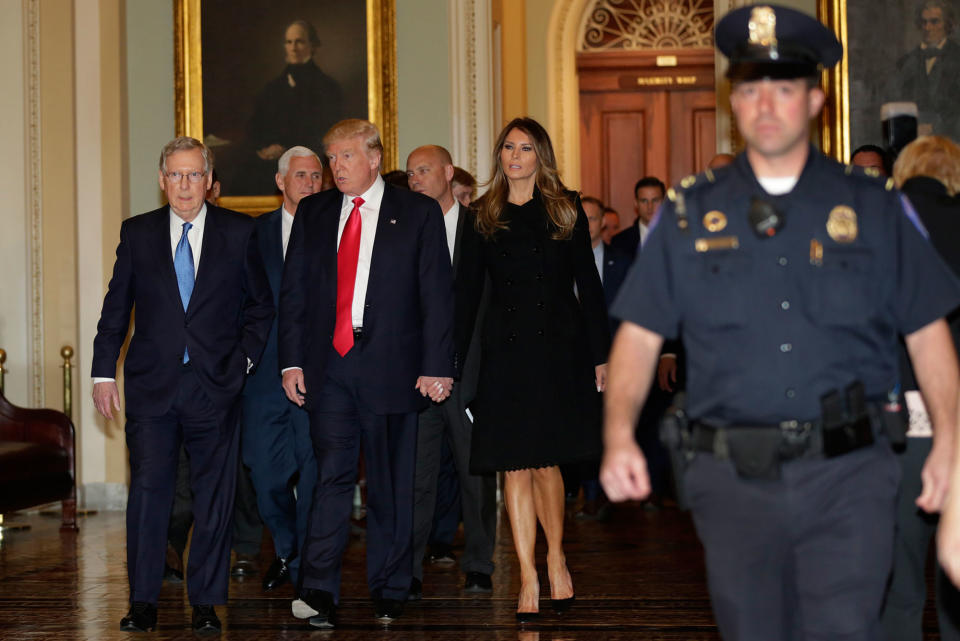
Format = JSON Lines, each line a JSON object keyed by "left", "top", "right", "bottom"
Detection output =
{"left": 578, "top": 50, "right": 716, "bottom": 226}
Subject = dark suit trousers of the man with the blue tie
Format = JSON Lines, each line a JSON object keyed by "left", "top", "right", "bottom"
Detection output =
{"left": 126, "top": 366, "right": 239, "bottom": 605}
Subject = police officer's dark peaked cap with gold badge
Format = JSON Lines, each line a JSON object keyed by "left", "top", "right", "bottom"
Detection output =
{"left": 716, "top": 4, "right": 843, "bottom": 80}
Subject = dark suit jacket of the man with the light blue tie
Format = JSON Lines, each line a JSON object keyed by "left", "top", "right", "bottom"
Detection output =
{"left": 93, "top": 203, "right": 274, "bottom": 417}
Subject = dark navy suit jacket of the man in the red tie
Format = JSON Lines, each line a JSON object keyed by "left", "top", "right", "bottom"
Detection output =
{"left": 279, "top": 185, "right": 455, "bottom": 414}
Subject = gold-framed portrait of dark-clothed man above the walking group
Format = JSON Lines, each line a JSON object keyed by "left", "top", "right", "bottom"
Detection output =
{"left": 174, "top": 0, "right": 397, "bottom": 213}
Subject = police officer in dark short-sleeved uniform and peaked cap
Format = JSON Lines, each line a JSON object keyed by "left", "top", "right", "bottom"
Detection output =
{"left": 601, "top": 5, "right": 960, "bottom": 641}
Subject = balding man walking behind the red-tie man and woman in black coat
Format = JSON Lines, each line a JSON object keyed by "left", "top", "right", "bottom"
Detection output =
{"left": 407, "top": 145, "right": 497, "bottom": 598}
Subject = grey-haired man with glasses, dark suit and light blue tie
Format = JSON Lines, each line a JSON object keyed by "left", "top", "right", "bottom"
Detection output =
{"left": 93, "top": 137, "right": 274, "bottom": 631}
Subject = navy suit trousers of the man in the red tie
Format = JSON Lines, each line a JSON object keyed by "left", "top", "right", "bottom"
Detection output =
{"left": 299, "top": 339, "right": 417, "bottom": 603}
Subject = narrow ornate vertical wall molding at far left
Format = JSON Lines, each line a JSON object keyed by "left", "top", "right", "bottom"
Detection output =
{"left": 24, "top": 0, "right": 45, "bottom": 407}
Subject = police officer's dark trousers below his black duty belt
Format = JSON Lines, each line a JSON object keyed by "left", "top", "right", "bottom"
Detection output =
{"left": 685, "top": 441, "right": 900, "bottom": 641}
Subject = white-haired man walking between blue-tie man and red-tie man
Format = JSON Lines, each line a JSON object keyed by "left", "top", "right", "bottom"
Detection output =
{"left": 240, "top": 146, "right": 323, "bottom": 591}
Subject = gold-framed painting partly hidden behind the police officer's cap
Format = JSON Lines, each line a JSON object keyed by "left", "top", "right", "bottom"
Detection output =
{"left": 818, "top": 0, "right": 960, "bottom": 162}
